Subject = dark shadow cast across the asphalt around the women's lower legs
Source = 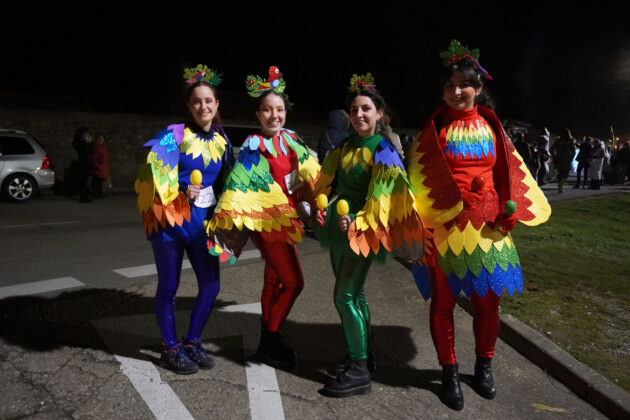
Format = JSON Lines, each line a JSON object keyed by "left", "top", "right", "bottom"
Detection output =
{"left": 0, "top": 289, "right": 441, "bottom": 394}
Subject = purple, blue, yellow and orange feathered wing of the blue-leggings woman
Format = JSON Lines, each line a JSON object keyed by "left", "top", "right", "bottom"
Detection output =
{"left": 134, "top": 124, "right": 190, "bottom": 235}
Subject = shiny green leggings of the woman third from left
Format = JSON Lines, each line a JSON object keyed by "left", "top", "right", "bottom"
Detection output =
{"left": 330, "top": 249, "right": 372, "bottom": 360}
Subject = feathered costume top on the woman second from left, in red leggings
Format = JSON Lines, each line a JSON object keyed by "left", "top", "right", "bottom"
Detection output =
{"left": 207, "top": 128, "right": 320, "bottom": 249}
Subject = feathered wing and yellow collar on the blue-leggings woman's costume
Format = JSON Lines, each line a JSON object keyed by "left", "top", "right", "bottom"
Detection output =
{"left": 134, "top": 124, "right": 227, "bottom": 235}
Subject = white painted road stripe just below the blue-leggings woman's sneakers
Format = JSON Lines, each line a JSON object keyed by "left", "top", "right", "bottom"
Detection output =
{"left": 116, "top": 356, "right": 193, "bottom": 420}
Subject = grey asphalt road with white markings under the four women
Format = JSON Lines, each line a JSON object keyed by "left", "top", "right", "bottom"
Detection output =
{"left": 0, "top": 194, "right": 603, "bottom": 419}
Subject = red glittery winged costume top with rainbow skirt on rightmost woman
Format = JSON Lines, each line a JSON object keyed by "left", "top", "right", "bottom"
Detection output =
{"left": 408, "top": 105, "right": 551, "bottom": 299}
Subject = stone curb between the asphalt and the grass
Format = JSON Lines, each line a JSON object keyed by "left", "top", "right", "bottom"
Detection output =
{"left": 457, "top": 297, "right": 630, "bottom": 419}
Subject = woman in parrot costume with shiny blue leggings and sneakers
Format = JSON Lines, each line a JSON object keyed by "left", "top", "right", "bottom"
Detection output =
{"left": 135, "top": 64, "right": 233, "bottom": 374}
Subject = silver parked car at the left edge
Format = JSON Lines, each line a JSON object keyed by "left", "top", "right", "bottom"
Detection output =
{"left": 0, "top": 129, "right": 55, "bottom": 202}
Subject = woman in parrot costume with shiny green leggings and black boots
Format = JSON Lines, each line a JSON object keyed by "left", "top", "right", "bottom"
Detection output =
{"left": 316, "top": 73, "right": 424, "bottom": 398}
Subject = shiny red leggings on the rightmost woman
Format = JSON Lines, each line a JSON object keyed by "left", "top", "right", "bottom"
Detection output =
{"left": 430, "top": 253, "right": 501, "bottom": 365}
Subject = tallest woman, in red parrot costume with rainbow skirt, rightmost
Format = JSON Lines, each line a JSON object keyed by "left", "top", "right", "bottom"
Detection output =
{"left": 408, "top": 40, "right": 551, "bottom": 410}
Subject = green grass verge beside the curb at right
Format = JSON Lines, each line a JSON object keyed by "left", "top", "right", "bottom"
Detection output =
{"left": 501, "top": 194, "right": 630, "bottom": 392}
